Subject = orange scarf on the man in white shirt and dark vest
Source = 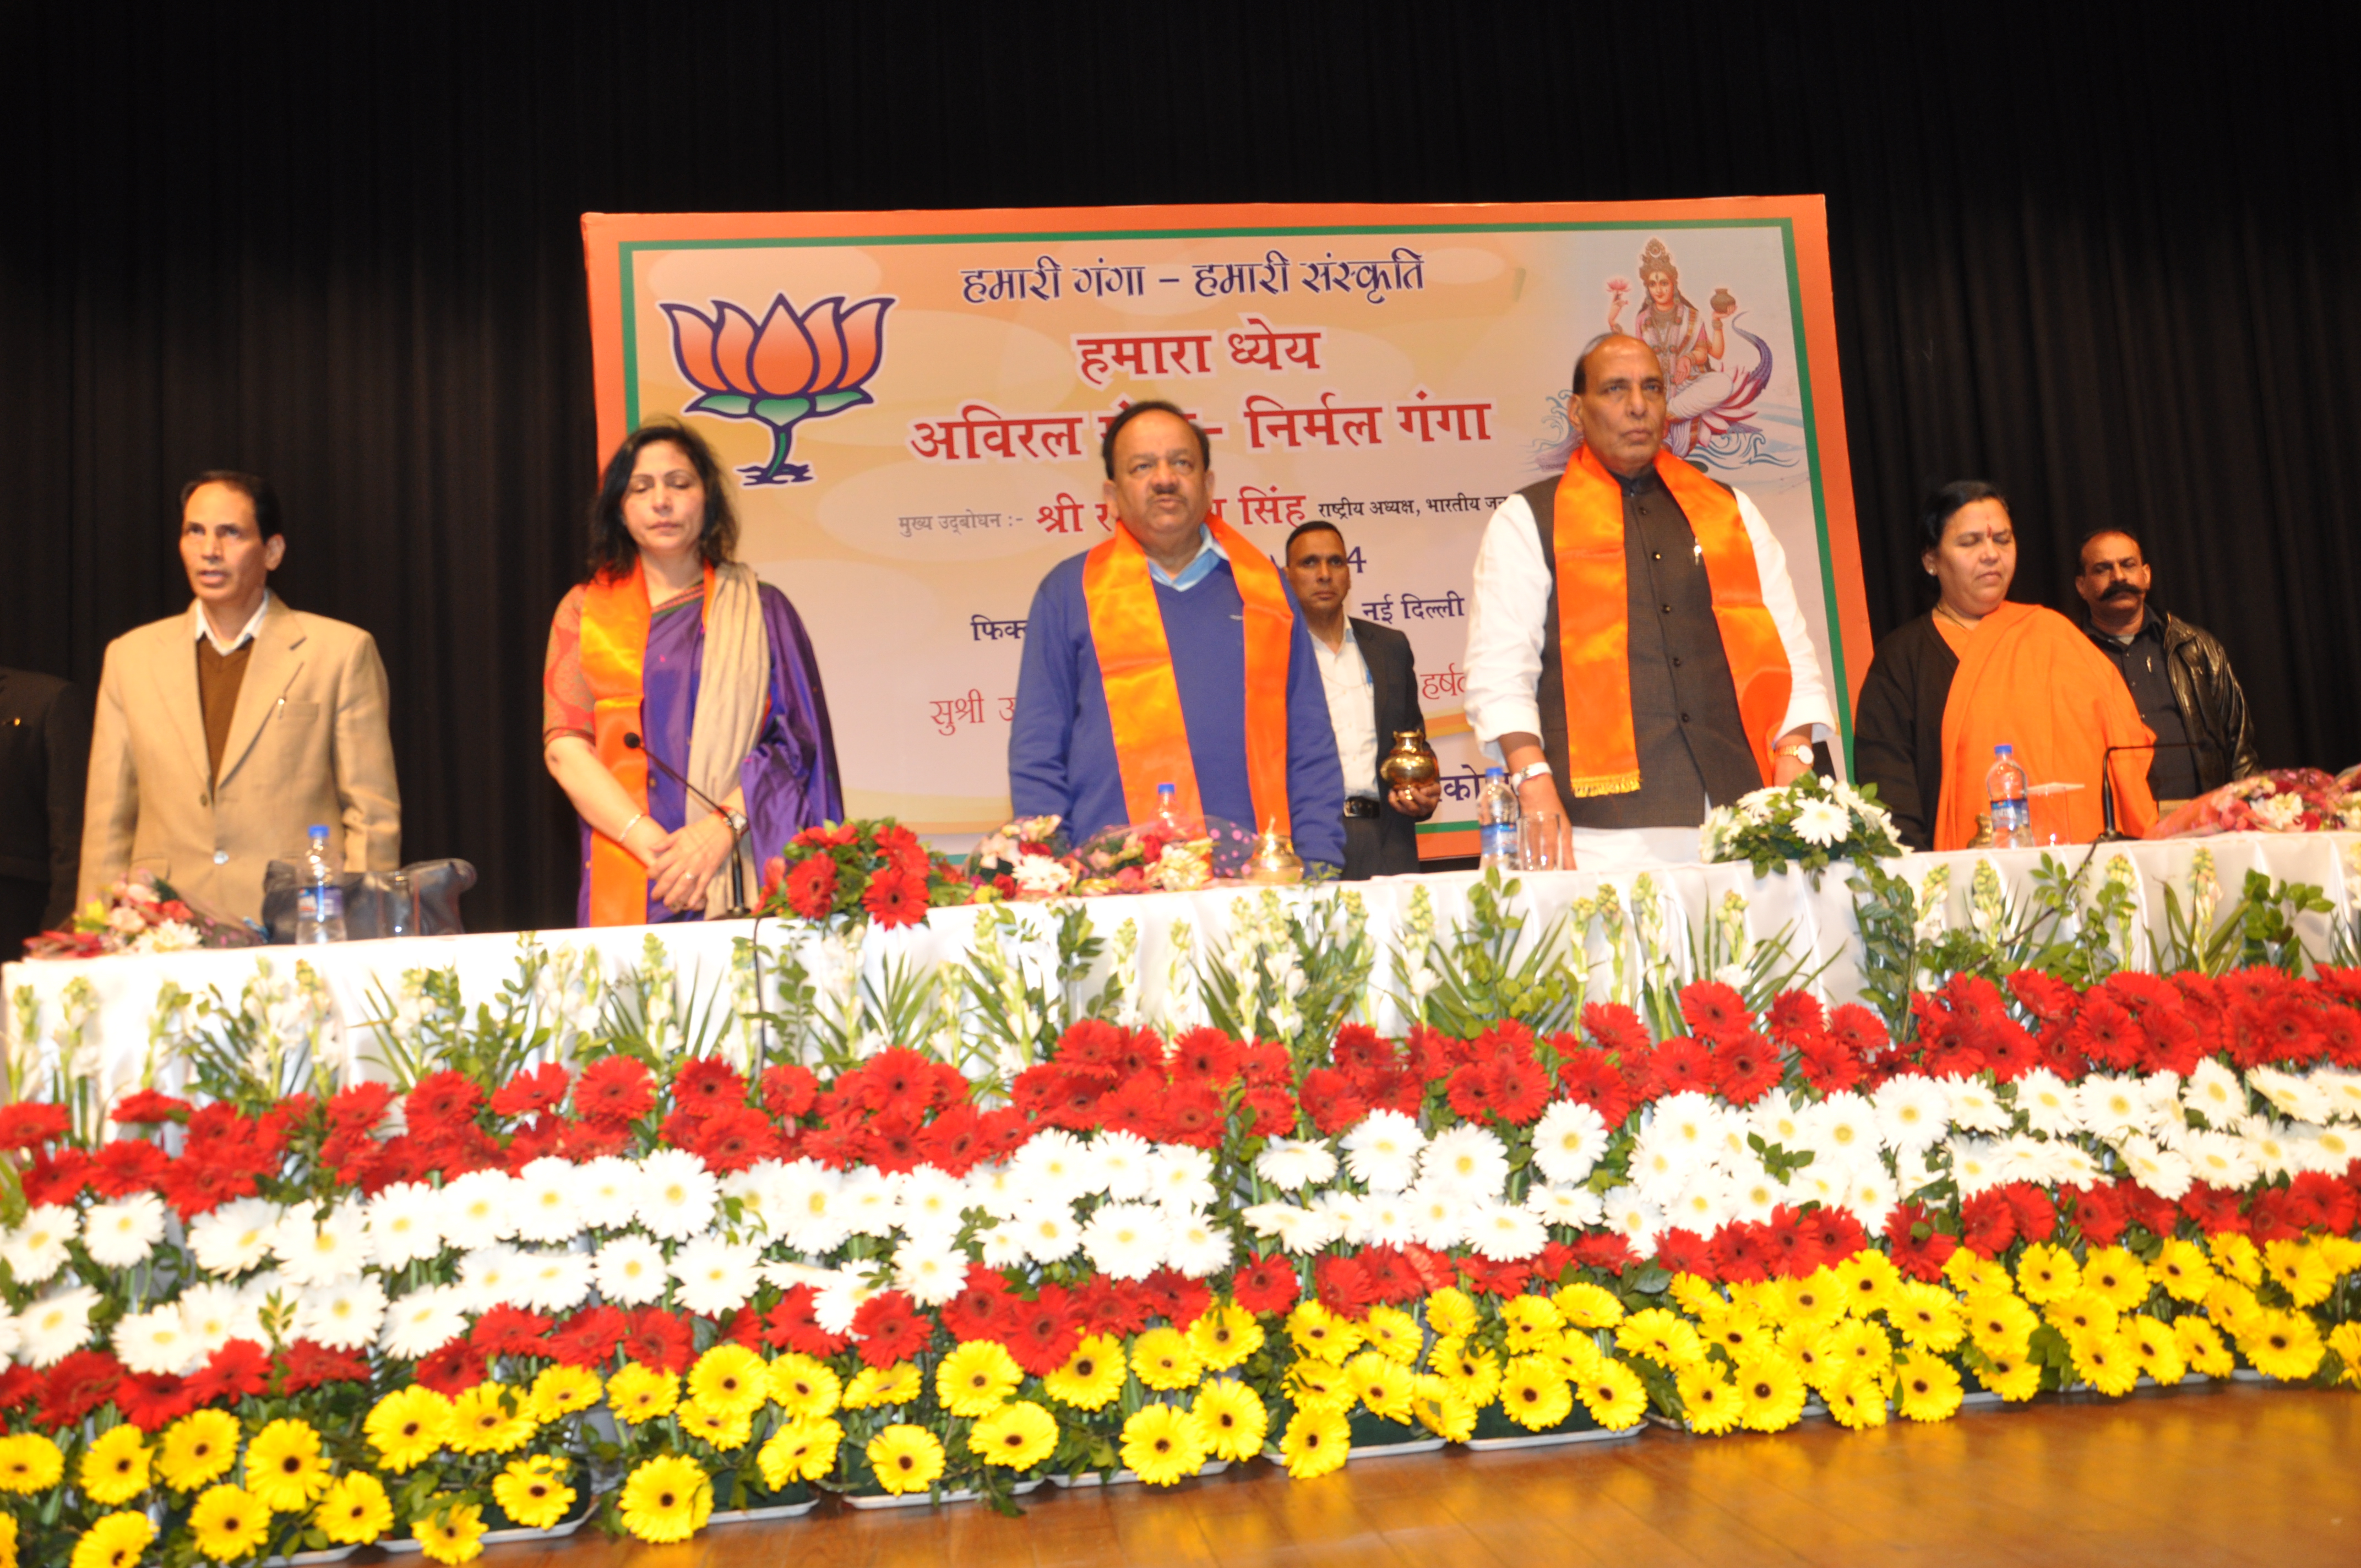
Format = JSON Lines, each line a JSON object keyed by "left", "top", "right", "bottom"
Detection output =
{"left": 1551, "top": 447, "right": 1794, "bottom": 798}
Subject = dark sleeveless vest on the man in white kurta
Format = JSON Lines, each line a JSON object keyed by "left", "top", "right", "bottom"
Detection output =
{"left": 1520, "top": 470, "right": 1764, "bottom": 829}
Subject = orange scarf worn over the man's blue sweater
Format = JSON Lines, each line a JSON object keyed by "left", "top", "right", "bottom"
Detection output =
{"left": 1081, "top": 517, "right": 1296, "bottom": 834}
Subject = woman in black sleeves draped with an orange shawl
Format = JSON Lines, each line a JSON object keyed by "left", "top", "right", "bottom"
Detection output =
{"left": 1853, "top": 480, "right": 2156, "bottom": 850}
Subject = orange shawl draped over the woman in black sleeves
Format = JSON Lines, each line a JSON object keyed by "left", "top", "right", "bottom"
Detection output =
{"left": 1934, "top": 605, "right": 2156, "bottom": 850}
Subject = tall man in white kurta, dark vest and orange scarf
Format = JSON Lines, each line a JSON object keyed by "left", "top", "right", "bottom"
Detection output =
{"left": 1466, "top": 335, "right": 1835, "bottom": 869}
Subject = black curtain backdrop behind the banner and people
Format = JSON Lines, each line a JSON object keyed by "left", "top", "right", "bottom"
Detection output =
{"left": 0, "top": 0, "right": 2361, "bottom": 928}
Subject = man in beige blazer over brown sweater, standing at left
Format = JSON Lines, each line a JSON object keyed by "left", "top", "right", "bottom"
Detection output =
{"left": 78, "top": 470, "right": 401, "bottom": 921}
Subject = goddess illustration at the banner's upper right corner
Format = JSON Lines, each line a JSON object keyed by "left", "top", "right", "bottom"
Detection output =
{"left": 1608, "top": 238, "right": 1773, "bottom": 465}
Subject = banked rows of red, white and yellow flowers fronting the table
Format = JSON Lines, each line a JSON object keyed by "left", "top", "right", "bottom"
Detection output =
{"left": 0, "top": 935, "right": 2361, "bottom": 1568}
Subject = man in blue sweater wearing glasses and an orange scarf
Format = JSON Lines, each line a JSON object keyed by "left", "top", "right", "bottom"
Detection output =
{"left": 1008, "top": 401, "right": 1343, "bottom": 869}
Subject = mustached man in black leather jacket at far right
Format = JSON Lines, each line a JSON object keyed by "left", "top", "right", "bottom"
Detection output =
{"left": 2073, "top": 529, "right": 2262, "bottom": 803}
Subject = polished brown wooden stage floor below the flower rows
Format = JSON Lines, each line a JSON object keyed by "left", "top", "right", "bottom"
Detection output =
{"left": 482, "top": 1386, "right": 2361, "bottom": 1568}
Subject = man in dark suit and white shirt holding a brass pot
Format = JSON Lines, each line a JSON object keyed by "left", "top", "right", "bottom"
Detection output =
{"left": 1287, "top": 517, "right": 1443, "bottom": 881}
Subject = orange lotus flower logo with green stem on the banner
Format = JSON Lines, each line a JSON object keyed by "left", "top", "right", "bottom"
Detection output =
{"left": 663, "top": 293, "right": 893, "bottom": 484}
